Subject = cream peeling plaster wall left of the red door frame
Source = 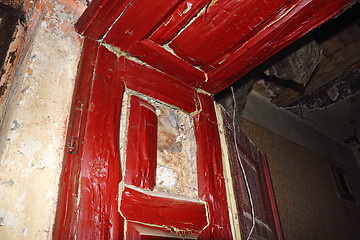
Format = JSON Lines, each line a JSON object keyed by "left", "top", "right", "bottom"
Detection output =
{"left": 0, "top": 0, "right": 86, "bottom": 239}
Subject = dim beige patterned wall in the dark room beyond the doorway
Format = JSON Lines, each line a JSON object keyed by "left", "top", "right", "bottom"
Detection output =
{"left": 241, "top": 119, "right": 360, "bottom": 239}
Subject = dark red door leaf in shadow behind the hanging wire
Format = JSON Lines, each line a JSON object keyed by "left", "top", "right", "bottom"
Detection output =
{"left": 222, "top": 110, "right": 282, "bottom": 239}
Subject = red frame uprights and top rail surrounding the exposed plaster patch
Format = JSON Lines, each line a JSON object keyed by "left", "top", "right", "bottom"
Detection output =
{"left": 53, "top": 38, "right": 232, "bottom": 239}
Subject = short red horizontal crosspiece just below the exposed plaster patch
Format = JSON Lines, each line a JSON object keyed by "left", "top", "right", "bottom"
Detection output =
{"left": 120, "top": 186, "right": 207, "bottom": 234}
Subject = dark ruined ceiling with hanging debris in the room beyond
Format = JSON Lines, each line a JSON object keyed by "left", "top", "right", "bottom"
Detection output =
{"left": 215, "top": 3, "right": 360, "bottom": 147}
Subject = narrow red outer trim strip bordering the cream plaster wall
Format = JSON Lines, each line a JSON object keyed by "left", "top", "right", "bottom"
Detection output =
{"left": 53, "top": 39, "right": 98, "bottom": 239}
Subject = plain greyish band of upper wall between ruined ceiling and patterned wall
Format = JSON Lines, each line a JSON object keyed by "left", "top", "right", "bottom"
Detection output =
{"left": 243, "top": 91, "right": 359, "bottom": 169}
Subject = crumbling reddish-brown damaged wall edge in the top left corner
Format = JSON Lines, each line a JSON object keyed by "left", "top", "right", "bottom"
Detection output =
{"left": 0, "top": 0, "right": 47, "bottom": 138}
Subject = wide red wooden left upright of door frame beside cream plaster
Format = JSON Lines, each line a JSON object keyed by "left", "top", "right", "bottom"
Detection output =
{"left": 53, "top": 38, "right": 124, "bottom": 239}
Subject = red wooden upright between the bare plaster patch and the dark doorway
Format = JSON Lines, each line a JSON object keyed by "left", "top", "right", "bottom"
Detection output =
{"left": 194, "top": 93, "right": 232, "bottom": 239}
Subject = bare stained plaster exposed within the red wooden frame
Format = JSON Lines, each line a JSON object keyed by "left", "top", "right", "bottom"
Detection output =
{"left": 120, "top": 90, "right": 198, "bottom": 198}
